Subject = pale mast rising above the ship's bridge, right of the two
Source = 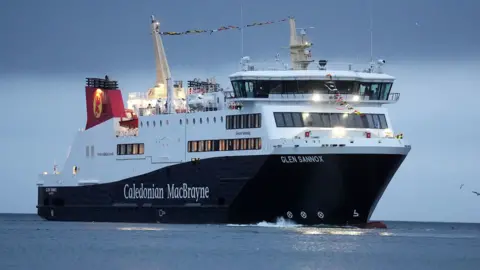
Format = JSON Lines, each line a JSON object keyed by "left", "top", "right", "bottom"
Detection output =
{"left": 289, "top": 17, "right": 313, "bottom": 70}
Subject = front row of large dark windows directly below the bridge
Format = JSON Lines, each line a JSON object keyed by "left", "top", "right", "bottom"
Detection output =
{"left": 274, "top": 112, "right": 388, "bottom": 129}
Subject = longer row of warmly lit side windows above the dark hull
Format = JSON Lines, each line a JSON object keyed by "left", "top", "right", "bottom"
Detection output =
{"left": 188, "top": 138, "right": 262, "bottom": 152}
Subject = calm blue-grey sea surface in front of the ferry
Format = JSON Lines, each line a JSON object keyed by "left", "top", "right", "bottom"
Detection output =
{"left": 0, "top": 215, "right": 480, "bottom": 270}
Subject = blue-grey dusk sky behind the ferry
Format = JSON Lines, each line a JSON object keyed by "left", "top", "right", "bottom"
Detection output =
{"left": 0, "top": 0, "right": 480, "bottom": 222}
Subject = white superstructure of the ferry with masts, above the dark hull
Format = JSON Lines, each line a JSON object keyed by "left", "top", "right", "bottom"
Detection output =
{"left": 37, "top": 17, "right": 410, "bottom": 186}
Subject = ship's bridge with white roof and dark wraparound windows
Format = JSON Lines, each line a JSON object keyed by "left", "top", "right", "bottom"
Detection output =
{"left": 230, "top": 70, "right": 400, "bottom": 103}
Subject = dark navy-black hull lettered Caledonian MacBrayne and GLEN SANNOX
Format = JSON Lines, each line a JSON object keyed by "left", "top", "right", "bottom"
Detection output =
{"left": 37, "top": 154, "right": 406, "bottom": 225}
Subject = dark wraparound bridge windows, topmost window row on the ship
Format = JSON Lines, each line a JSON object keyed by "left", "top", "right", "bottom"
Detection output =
{"left": 232, "top": 80, "right": 392, "bottom": 100}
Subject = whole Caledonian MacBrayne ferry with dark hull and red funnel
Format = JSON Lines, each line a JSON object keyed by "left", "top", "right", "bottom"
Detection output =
{"left": 37, "top": 17, "right": 410, "bottom": 225}
